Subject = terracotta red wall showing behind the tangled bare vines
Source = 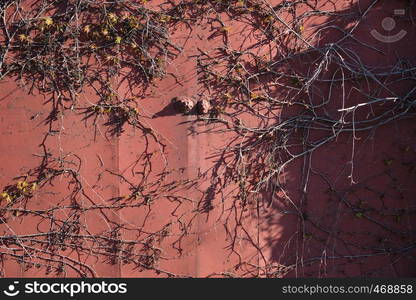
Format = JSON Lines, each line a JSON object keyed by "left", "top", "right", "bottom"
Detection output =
{"left": 0, "top": 1, "right": 416, "bottom": 277}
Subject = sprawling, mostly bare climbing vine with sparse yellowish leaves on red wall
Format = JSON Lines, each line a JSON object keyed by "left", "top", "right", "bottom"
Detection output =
{"left": 0, "top": 0, "right": 416, "bottom": 277}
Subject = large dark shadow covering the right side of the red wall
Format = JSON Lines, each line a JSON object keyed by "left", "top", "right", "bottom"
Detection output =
{"left": 261, "top": 1, "right": 416, "bottom": 277}
